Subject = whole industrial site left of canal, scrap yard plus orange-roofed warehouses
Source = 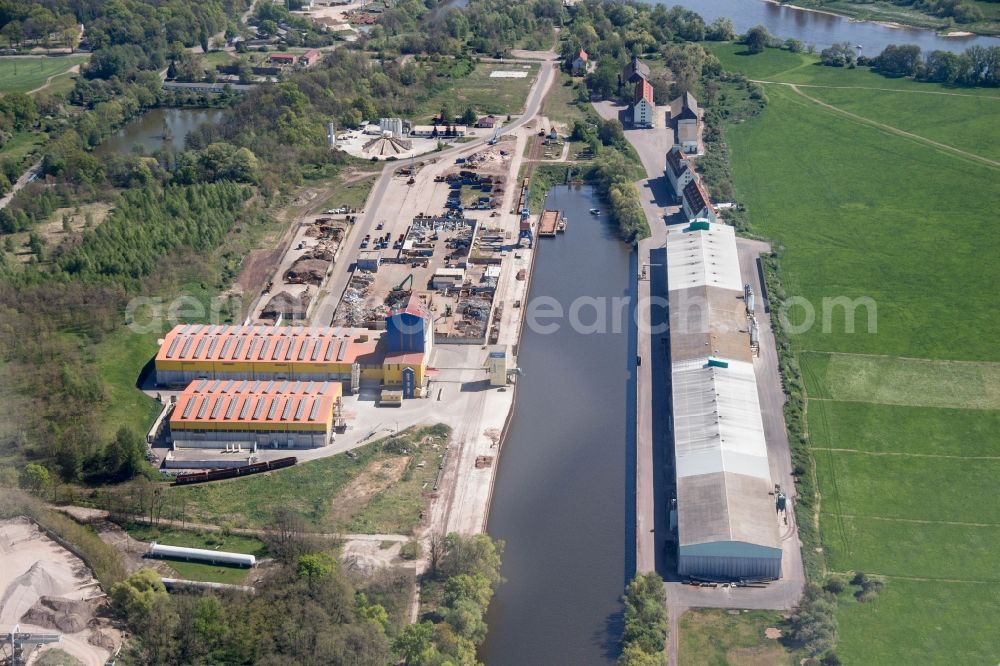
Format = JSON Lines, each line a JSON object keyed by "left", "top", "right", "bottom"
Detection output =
{"left": 139, "top": 54, "right": 555, "bottom": 534}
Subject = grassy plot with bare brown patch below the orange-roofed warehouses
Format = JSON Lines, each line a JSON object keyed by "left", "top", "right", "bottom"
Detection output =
{"left": 165, "top": 425, "right": 450, "bottom": 534}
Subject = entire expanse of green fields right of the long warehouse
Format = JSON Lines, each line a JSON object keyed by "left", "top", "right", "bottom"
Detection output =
{"left": 711, "top": 45, "right": 1000, "bottom": 664}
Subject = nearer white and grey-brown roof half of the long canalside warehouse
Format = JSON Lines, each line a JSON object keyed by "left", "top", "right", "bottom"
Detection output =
{"left": 672, "top": 357, "right": 780, "bottom": 548}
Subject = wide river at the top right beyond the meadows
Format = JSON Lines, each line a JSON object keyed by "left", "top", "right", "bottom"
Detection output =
{"left": 648, "top": 0, "right": 1000, "bottom": 56}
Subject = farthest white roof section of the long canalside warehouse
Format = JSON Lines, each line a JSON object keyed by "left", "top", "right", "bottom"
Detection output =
{"left": 667, "top": 221, "right": 743, "bottom": 293}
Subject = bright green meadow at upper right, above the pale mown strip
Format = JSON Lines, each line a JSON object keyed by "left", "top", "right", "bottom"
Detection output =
{"left": 714, "top": 45, "right": 1000, "bottom": 361}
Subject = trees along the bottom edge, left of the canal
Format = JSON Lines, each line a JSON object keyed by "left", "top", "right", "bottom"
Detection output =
{"left": 110, "top": 518, "right": 502, "bottom": 666}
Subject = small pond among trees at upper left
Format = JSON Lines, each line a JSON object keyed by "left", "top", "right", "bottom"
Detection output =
{"left": 94, "top": 109, "right": 223, "bottom": 155}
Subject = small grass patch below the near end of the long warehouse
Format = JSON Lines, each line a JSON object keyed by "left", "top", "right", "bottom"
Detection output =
{"left": 678, "top": 608, "right": 798, "bottom": 666}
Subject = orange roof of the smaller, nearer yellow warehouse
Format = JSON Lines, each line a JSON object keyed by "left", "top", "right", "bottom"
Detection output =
{"left": 170, "top": 379, "right": 343, "bottom": 428}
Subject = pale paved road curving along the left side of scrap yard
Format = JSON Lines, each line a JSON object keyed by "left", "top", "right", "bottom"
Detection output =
{"left": 312, "top": 60, "right": 555, "bottom": 326}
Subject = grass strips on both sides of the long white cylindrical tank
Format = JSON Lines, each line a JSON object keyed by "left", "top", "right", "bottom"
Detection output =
{"left": 125, "top": 523, "right": 267, "bottom": 585}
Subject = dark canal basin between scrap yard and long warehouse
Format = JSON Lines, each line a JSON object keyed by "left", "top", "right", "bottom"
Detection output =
{"left": 481, "top": 186, "right": 635, "bottom": 666}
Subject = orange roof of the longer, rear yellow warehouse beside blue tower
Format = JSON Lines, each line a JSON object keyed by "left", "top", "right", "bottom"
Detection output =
{"left": 156, "top": 324, "right": 381, "bottom": 363}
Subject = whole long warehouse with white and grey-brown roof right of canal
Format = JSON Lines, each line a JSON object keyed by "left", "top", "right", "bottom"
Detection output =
{"left": 667, "top": 217, "right": 782, "bottom": 580}
